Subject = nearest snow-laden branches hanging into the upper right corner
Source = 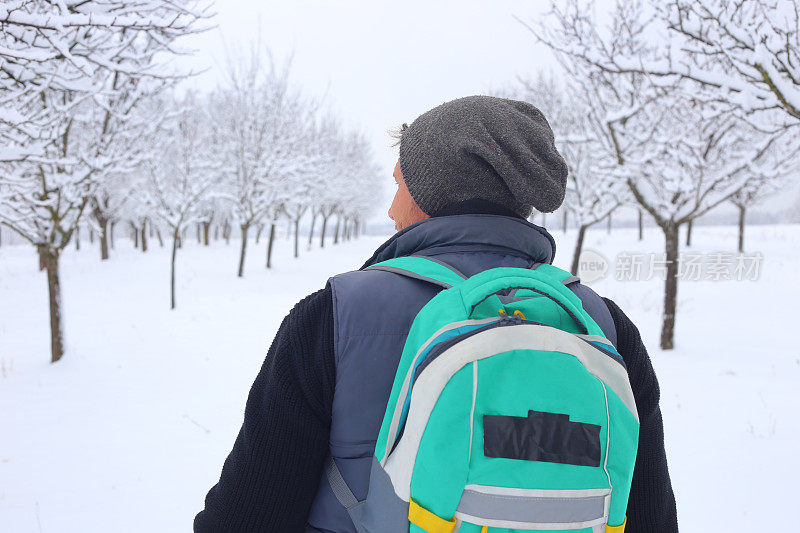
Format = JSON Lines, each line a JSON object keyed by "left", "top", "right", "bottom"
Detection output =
{"left": 656, "top": 0, "right": 800, "bottom": 127}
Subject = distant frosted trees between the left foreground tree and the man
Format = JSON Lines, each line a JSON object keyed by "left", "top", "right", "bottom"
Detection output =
{"left": 97, "top": 50, "right": 380, "bottom": 308}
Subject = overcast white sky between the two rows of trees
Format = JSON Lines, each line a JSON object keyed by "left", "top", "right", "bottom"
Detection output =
{"left": 178, "top": 0, "right": 796, "bottom": 219}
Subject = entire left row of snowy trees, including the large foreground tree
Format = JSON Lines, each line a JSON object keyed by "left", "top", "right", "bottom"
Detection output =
{"left": 0, "top": 0, "right": 376, "bottom": 361}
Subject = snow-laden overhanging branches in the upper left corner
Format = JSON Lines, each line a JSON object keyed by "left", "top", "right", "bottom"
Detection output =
{"left": 0, "top": 0, "right": 210, "bottom": 154}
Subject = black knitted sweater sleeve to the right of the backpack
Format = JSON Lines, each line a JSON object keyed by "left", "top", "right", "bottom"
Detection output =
{"left": 603, "top": 298, "right": 678, "bottom": 533}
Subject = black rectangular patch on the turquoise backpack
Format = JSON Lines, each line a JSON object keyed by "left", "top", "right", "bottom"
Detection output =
{"left": 483, "top": 411, "right": 600, "bottom": 466}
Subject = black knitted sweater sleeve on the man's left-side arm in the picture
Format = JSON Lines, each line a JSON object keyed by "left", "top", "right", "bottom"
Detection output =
{"left": 194, "top": 287, "right": 335, "bottom": 533}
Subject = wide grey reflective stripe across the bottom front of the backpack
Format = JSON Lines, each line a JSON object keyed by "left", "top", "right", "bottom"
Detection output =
{"left": 456, "top": 485, "right": 611, "bottom": 529}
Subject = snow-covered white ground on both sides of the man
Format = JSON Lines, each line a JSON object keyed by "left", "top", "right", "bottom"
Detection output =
{"left": 0, "top": 225, "right": 800, "bottom": 533}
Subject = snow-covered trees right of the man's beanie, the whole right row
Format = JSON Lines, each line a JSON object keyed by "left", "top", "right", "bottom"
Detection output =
{"left": 516, "top": 0, "right": 800, "bottom": 349}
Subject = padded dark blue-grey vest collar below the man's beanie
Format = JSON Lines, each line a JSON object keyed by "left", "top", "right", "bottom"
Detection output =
{"left": 361, "top": 214, "right": 556, "bottom": 270}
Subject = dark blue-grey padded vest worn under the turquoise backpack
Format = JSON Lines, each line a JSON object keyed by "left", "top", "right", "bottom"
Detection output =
{"left": 306, "top": 214, "right": 617, "bottom": 533}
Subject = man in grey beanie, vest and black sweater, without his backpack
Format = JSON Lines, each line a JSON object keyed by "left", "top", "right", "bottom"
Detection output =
{"left": 194, "top": 96, "right": 677, "bottom": 533}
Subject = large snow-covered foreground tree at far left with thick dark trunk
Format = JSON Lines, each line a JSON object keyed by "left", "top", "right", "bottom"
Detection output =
{"left": 0, "top": 0, "right": 211, "bottom": 362}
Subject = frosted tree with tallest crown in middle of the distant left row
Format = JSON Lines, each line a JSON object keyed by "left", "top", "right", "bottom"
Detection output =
{"left": 211, "top": 45, "right": 313, "bottom": 277}
